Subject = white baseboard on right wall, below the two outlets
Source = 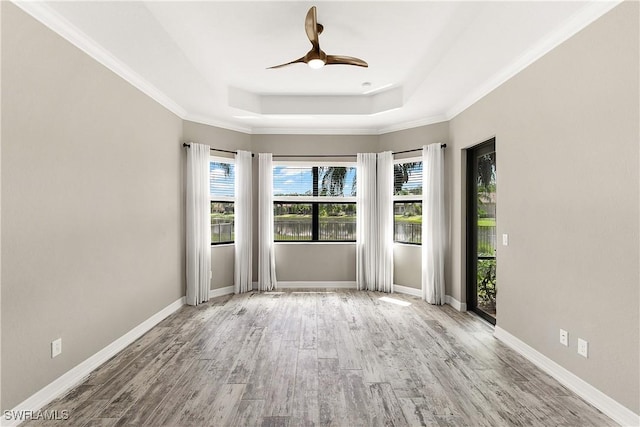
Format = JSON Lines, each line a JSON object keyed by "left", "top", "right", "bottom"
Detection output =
{"left": 493, "top": 326, "right": 640, "bottom": 426}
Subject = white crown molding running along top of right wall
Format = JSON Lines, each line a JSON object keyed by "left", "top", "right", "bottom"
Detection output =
{"left": 446, "top": 0, "right": 622, "bottom": 120}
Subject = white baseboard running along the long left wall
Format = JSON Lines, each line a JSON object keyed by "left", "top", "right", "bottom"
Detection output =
{"left": 0, "top": 297, "right": 185, "bottom": 427}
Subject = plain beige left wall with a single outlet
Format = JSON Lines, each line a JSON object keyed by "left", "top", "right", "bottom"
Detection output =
{"left": 1, "top": 2, "right": 184, "bottom": 409}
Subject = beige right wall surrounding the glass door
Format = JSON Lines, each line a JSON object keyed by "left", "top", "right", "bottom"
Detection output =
{"left": 447, "top": 2, "right": 640, "bottom": 413}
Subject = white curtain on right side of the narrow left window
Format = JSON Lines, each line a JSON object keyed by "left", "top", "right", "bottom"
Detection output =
{"left": 234, "top": 150, "right": 253, "bottom": 294}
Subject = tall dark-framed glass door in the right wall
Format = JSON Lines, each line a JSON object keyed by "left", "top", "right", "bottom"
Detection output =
{"left": 466, "top": 138, "right": 497, "bottom": 325}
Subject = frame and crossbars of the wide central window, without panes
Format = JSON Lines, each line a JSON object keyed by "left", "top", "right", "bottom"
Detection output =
{"left": 272, "top": 161, "right": 357, "bottom": 243}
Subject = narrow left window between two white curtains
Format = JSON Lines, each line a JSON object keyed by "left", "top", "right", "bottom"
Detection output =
{"left": 209, "top": 157, "right": 235, "bottom": 245}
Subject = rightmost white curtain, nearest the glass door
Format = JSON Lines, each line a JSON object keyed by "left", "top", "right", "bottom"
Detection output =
{"left": 422, "top": 143, "right": 446, "bottom": 304}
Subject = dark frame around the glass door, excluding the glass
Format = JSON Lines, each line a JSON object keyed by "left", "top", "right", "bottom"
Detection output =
{"left": 465, "top": 137, "right": 496, "bottom": 325}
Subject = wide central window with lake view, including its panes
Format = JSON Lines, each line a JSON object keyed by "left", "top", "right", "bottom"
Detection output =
{"left": 273, "top": 162, "right": 356, "bottom": 242}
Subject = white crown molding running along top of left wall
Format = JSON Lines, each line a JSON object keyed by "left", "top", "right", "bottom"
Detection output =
{"left": 12, "top": 0, "right": 187, "bottom": 119}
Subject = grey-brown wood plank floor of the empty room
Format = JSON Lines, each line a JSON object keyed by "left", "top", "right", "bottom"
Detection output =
{"left": 24, "top": 290, "right": 616, "bottom": 427}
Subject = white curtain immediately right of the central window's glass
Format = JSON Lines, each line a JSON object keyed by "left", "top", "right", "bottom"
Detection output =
{"left": 356, "top": 153, "right": 378, "bottom": 289}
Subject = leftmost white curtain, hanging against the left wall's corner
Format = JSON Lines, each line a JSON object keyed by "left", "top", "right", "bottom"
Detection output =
{"left": 186, "top": 143, "right": 211, "bottom": 305}
